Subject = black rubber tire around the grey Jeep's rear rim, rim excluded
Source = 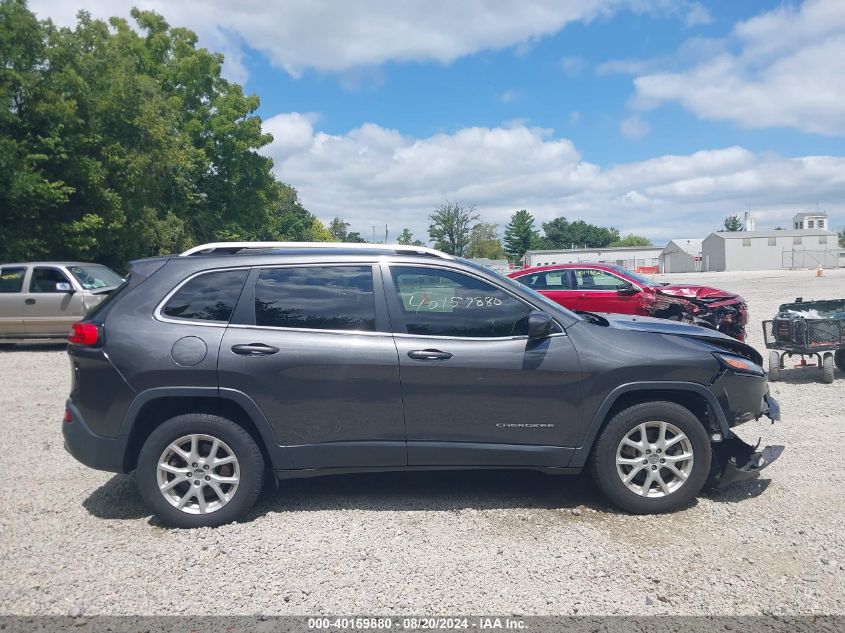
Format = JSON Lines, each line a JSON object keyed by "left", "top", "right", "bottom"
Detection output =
{"left": 135, "top": 413, "right": 264, "bottom": 528}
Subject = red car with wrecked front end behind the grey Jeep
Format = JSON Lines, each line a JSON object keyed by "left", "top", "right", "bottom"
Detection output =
{"left": 508, "top": 262, "right": 748, "bottom": 341}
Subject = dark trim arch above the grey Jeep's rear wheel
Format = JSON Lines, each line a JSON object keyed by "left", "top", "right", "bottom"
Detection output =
{"left": 121, "top": 387, "right": 291, "bottom": 472}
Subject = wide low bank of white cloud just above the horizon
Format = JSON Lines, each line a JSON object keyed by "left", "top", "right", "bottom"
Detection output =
{"left": 268, "top": 113, "right": 845, "bottom": 240}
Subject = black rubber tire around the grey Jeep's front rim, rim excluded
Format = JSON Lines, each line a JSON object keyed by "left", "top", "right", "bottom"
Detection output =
{"left": 590, "top": 401, "right": 712, "bottom": 514}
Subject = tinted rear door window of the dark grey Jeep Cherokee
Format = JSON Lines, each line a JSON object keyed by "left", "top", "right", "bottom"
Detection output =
{"left": 255, "top": 266, "right": 376, "bottom": 332}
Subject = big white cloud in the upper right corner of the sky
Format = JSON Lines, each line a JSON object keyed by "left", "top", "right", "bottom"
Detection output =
{"left": 628, "top": 0, "right": 845, "bottom": 135}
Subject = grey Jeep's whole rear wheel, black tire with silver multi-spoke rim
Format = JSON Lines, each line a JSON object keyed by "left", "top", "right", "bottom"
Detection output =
{"left": 136, "top": 414, "right": 264, "bottom": 528}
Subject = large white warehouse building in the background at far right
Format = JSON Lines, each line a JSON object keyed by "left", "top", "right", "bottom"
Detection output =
{"left": 700, "top": 228, "right": 842, "bottom": 272}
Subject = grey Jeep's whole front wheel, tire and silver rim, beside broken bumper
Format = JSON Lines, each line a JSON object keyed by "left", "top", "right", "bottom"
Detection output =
{"left": 590, "top": 401, "right": 711, "bottom": 514}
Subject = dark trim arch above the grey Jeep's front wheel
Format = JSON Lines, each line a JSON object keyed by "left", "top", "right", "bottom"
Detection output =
{"left": 569, "top": 381, "right": 732, "bottom": 468}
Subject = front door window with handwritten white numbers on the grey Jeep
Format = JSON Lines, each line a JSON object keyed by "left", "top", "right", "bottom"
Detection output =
{"left": 390, "top": 266, "right": 531, "bottom": 338}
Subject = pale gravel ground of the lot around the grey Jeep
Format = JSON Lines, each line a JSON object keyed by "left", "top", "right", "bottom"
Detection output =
{"left": 0, "top": 270, "right": 845, "bottom": 615}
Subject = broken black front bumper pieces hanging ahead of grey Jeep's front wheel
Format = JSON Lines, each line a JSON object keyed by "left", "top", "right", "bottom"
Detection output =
{"left": 708, "top": 394, "right": 784, "bottom": 488}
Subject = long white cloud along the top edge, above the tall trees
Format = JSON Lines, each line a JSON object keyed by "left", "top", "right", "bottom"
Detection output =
{"left": 30, "top": 0, "right": 720, "bottom": 76}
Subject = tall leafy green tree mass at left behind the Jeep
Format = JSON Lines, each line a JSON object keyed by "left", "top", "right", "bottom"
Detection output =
{"left": 0, "top": 0, "right": 319, "bottom": 267}
